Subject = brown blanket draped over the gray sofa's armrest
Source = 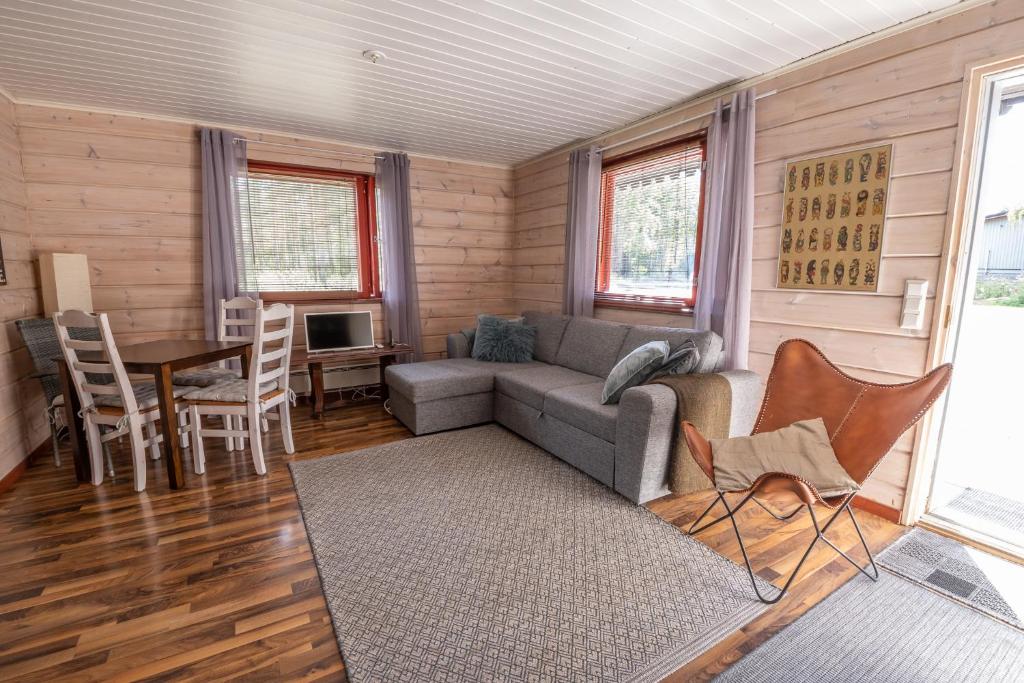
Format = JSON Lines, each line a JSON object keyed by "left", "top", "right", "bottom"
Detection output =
{"left": 650, "top": 374, "right": 732, "bottom": 494}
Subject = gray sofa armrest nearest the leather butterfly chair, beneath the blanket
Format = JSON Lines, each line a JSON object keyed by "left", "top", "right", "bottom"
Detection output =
{"left": 615, "top": 370, "right": 764, "bottom": 503}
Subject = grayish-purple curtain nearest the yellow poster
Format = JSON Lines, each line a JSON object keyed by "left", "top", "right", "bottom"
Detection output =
{"left": 693, "top": 89, "right": 755, "bottom": 370}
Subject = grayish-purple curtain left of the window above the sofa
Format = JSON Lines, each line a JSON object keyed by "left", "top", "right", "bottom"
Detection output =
{"left": 562, "top": 146, "right": 601, "bottom": 317}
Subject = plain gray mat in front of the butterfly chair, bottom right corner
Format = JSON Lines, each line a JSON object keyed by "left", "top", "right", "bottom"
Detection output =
{"left": 716, "top": 571, "right": 1024, "bottom": 683}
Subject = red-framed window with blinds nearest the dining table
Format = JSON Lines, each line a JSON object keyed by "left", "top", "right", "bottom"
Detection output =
{"left": 238, "top": 162, "right": 380, "bottom": 300}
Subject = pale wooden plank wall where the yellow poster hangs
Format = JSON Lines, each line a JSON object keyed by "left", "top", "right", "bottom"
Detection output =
{"left": 515, "top": 2, "right": 1024, "bottom": 508}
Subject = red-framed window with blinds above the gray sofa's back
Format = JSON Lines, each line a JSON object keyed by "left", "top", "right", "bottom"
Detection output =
{"left": 594, "top": 133, "right": 707, "bottom": 311}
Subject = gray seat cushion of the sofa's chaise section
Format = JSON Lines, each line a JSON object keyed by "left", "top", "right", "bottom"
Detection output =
{"left": 384, "top": 358, "right": 541, "bottom": 403}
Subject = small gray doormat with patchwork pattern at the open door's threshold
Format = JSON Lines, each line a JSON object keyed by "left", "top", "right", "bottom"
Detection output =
{"left": 877, "top": 528, "right": 1024, "bottom": 629}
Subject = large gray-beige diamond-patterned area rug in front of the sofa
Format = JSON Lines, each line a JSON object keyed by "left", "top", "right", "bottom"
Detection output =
{"left": 291, "top": 425, "right": 764, "bottom": 681}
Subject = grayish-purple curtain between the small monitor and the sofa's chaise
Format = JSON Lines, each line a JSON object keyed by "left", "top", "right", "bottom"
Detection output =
{"left": 377, "top": 152, "right": 423, "bottom": 360}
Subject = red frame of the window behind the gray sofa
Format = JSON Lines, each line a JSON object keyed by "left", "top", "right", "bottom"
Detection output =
{"left": 594, "top": 130, "right": 708, "bottom": 313}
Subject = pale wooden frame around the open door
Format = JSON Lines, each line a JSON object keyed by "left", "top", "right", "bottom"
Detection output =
{"left": 900, "top": 52, "right": 1024, "bottom": 524}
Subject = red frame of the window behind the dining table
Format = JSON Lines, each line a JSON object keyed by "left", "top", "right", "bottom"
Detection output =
{"left": 248, "top": 161, "right": 381, "bottom": 303}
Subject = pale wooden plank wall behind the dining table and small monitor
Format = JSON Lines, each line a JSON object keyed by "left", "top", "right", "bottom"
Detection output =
{"left": 17, "top": 104, "right": 512, "bottom": 368}
